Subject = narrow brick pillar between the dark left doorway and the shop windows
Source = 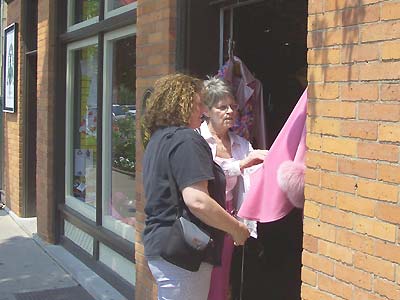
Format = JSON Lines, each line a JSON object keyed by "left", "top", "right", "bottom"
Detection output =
{"left": 36, "top": 0, "right": 56, "bottom": 243}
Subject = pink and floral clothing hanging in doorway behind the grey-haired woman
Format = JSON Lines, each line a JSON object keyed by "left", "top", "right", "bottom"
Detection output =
{"left": 217, "top": 56, "right": 267, "bottom": 149}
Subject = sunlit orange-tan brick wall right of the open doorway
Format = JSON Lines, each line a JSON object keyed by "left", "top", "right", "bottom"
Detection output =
{"left": 302, "top": 0, "right": 400, "bottom": 300}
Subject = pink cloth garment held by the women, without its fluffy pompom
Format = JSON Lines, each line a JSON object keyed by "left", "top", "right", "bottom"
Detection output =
{"left": 238, "top": 89, "right": 307, "bottom": 223}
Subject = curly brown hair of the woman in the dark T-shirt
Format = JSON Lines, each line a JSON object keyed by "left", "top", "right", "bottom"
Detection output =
{"left": 143, "top": 73, "right": 202, "bottom": 144}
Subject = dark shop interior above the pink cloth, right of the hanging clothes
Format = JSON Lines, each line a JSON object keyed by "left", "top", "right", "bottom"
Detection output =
{"left": 233, "top": 0, "right": 307, "bottom": 146}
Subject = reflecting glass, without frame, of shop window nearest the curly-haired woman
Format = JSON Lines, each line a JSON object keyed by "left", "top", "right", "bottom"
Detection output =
{"left": 109, "top": 36, "right": 136, "bottom": 225}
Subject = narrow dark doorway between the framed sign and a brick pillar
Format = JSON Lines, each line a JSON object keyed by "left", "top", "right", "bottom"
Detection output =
{"left": 24, "top": 0, "right": 38, "bottom": 217}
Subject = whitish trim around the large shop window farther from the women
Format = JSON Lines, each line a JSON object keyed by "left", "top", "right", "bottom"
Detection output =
{"left": 65, "top": 36, "right": 98, "bottom": 221}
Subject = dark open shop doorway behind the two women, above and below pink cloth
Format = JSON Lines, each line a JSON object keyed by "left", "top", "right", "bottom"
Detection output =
{"left": 183, "top": 0, "right": 308, "bottom": 300}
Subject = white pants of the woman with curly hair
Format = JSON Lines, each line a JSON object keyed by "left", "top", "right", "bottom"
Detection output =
{"left": 148, "top": 258, "right": 213, "bottom": 300}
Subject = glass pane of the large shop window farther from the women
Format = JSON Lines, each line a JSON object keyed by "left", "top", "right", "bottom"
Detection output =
{"left": 67, "top": 45, "right": 97, "bottom": 207}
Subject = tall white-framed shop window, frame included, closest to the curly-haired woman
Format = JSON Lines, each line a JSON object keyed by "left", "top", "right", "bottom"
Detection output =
{"left": 103, "top": 28, "right": 136, "bottom": 241}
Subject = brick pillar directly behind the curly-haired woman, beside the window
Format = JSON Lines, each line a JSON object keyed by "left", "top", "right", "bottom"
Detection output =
{"left": 135, "top": 0, "right": 176, "bottom": 300}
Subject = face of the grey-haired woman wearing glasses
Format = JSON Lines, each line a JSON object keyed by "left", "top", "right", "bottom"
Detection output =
{"left": 208, "top": 96, "right": 238, "bottom": 130}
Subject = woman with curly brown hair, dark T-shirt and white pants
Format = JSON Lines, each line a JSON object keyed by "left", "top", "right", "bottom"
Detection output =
{"left": 143, "top": 74, "right": 249, "bottom": 300}
